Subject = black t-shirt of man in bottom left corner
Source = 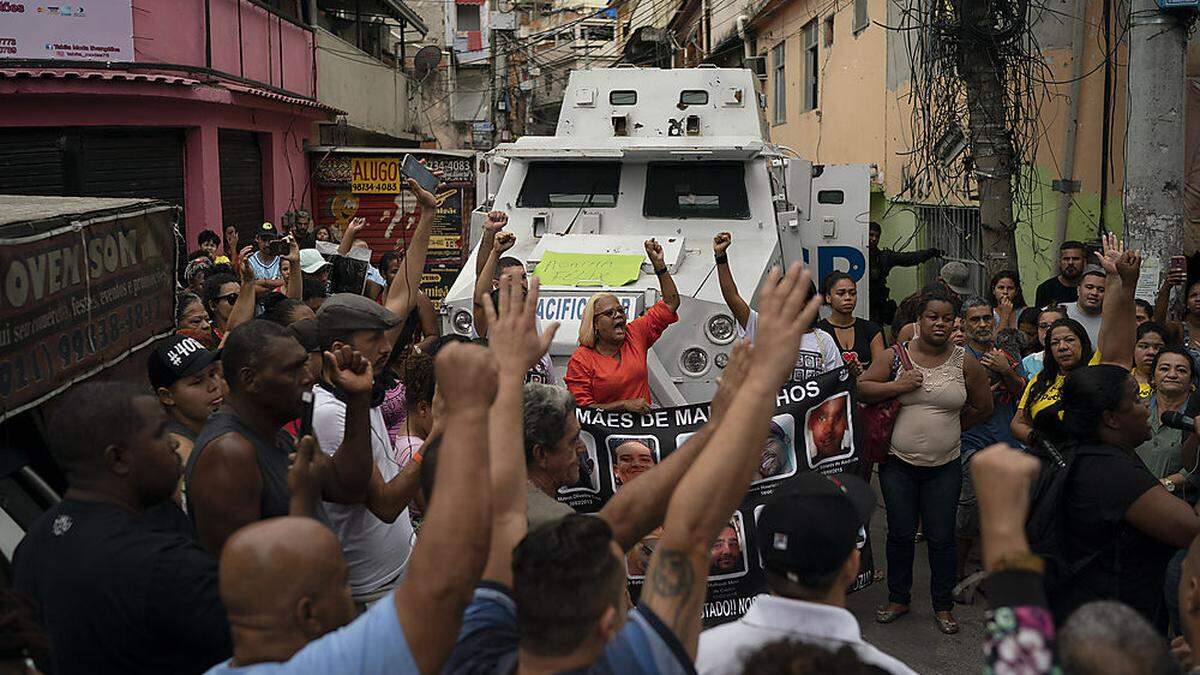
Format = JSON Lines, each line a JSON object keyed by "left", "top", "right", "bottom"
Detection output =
{"left": 13, "top": 500, "right": 233, "bottom": 675}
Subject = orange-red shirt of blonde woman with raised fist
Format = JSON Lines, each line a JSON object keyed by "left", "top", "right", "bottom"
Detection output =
{"left": 565, "top": 300, "right": 679, "bottom": 406}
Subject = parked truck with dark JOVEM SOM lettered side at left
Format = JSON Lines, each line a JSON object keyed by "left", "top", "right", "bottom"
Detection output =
{"left": 0, "top": 196, "right": 180, "bottom": 578}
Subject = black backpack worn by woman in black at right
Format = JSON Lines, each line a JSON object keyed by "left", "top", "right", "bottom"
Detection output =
{"left": 1025, "top": 440, "right": 1099, "bottom": 595}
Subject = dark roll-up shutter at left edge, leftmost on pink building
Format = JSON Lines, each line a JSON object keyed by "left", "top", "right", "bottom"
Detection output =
{"left": 0, "top": 127, "right": 67, "bottom": 196}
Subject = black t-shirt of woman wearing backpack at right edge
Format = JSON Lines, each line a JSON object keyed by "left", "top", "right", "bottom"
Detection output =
{"left": 1052, "top": 444, "right": 1175, "bottom": 623}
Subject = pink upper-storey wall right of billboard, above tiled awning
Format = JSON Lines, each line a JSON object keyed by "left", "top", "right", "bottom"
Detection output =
{"left": 133, "top": 0, "right": 317, "bottom": 97}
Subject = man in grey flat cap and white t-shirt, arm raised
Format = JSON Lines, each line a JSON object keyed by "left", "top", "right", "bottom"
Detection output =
{"left": 312, "top": 293, "right": 420, "bottom": 604}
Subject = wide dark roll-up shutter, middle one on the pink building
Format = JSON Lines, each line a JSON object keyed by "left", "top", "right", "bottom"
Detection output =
{"left": 77, "top": 127, "right": 184, "bottom": 207}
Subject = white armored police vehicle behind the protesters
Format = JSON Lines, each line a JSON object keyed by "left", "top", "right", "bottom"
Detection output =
{"left": 443, "top": 67, "right": 870, "bottom": 406}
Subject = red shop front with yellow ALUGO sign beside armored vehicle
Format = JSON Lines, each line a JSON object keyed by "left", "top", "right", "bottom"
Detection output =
{"left": 310, "top": 148, "right": 476, "bottom": 307}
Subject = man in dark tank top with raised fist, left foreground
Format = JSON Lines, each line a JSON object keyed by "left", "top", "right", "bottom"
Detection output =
{"left": 185, "top": 319, "right": 373, "bottom": 555}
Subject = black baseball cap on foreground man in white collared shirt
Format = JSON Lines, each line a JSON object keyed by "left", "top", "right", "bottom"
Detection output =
{"left": 756, "top": 472, "right": 875, "bottom": 583}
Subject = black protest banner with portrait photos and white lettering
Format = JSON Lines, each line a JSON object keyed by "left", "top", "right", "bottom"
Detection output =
{"left": 558, "top": 368, "right": 874, "bottom": 626}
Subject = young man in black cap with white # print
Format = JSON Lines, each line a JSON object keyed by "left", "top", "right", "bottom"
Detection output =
{"left": 146, "top": 335, "right": 226, "bottom": 462}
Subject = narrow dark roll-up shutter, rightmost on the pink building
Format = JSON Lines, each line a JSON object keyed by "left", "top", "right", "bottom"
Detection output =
{"left": 217, "top": 129, "right": 268, "bottom": 239}
